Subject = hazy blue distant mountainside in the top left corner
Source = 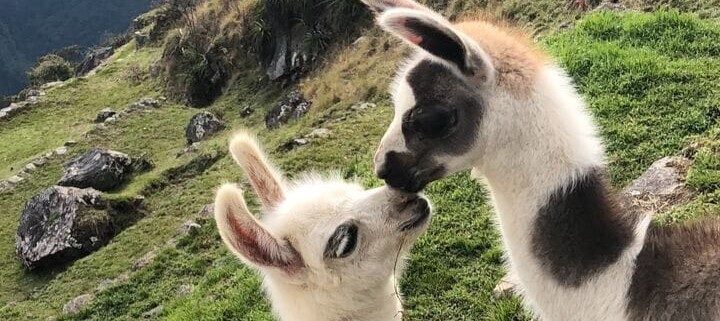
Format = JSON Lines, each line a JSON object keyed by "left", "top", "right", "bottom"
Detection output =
{"left": 0, "top": 0, "right": 150, "bottom": 95}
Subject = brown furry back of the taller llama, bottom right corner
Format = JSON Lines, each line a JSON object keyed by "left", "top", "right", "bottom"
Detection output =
{"left": 627, "top": 220, "right": 720, "bottom": 321}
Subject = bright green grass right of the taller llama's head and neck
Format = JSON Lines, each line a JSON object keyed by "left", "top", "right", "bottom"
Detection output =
{"left": 544, "top": 12, "right": 720, "bottom": 185}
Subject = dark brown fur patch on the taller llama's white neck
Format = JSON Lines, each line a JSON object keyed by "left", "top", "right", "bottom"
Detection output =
{"left": 532, "top": 169, "right": 637, "bottom": 287}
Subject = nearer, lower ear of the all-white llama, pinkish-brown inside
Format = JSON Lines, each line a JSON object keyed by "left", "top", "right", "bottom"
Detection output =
{"left": 215, "top": 184, "right": 303, "bottom": 274}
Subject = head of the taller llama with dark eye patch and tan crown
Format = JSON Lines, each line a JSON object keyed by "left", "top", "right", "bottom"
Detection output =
{"left": 364, "top": 0, "right": 542, "bottom": 192}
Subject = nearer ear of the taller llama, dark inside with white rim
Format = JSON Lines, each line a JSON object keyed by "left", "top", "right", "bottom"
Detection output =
{"left": 378, "top": 8, "right": 493, "bottom": 76}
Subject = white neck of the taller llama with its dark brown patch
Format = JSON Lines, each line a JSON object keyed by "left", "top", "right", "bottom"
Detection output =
{"left": 475, "top": 66, "right": 646, "bottom": 320}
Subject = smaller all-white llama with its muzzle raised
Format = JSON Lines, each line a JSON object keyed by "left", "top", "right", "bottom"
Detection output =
{"left": 215, "top": 133, "right": 430, "bottom": 321}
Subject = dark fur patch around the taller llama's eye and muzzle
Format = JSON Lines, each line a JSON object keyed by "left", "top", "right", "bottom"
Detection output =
{"left": 378, "top": 60, "right": 485, "bottom": 193}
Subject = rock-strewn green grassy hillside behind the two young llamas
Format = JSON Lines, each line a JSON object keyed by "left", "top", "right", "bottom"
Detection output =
{"left": 0, "top": 0, "right": 720, "bottom": 320}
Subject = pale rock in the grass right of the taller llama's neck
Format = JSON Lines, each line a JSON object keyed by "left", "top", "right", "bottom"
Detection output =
{"left": 622, "top": 157, "right": 693, "bottom": 215}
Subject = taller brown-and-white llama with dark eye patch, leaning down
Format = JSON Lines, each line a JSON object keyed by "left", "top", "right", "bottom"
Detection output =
{"left": 365, "top": 0, "right": 720, "bottom": 321}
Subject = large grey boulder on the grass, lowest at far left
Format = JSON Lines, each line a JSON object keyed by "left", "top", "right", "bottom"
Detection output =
{"left": 15, "top": 186, "right": 112, "bottom": 269}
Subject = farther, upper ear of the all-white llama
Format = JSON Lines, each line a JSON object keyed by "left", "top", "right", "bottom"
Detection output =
{"left": 230, "top": 131, "right": 285, "bottom": 210}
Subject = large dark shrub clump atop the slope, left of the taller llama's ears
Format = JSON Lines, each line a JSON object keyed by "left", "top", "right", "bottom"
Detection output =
{"left": 162, "top": 0, "right": 370, "bottom": 106}
